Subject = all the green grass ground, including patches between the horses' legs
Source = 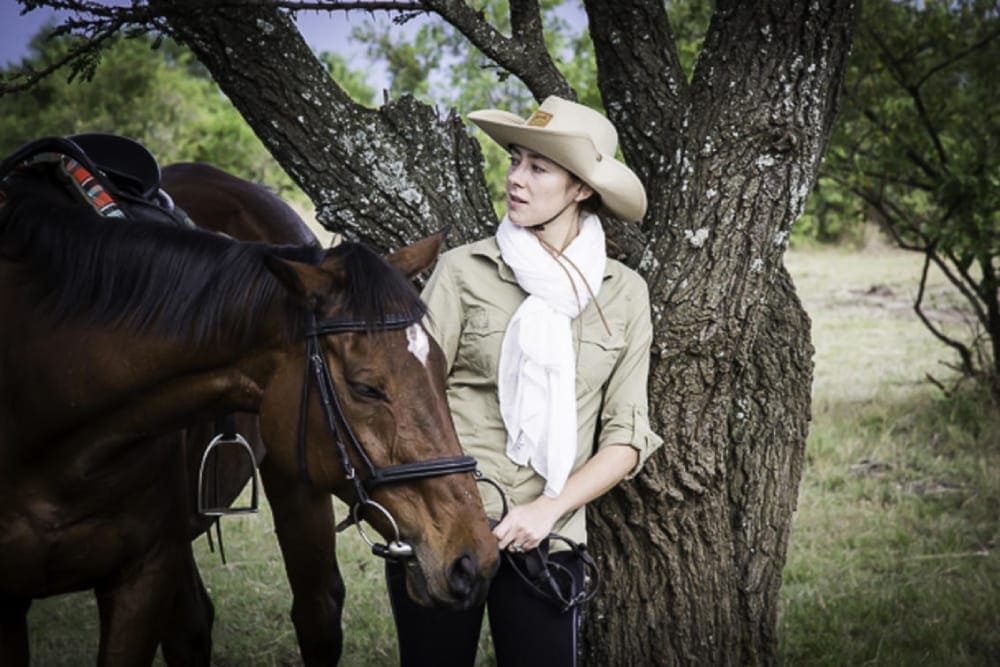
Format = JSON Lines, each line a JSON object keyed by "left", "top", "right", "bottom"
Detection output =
{"left": 25, "top": 250, "right": 1000, "bottom": 667}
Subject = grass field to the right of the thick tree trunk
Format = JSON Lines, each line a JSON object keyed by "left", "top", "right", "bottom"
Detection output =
{"left": 779, "top": 245, "right": 1000, "bottom": 665}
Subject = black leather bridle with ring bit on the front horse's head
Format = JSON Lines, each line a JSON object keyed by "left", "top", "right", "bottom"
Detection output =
{"left": 297, "top": 311, "right": 476, "bottom": 559}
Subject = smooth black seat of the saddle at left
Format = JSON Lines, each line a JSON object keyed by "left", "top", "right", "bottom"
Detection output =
{"left": 68, "top": 132, "right": 160, "bottom": 201}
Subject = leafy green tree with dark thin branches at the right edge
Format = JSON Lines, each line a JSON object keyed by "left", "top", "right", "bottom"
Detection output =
{"left": 826, "top": 0, "right": 1000, "bottom": 398}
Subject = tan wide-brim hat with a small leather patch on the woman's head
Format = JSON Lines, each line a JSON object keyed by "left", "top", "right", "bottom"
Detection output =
{"left": 469, "top": 95, "right": 646, "bottom": 222}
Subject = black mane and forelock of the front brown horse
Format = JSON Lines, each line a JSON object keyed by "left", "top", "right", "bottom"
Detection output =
{"left": 0, "top": 180, "right": 423, "bottom": 346}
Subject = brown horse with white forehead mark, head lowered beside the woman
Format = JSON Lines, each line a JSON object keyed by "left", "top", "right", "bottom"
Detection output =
{"left": 0, "top": 159, "right": 498, "bottom": 665}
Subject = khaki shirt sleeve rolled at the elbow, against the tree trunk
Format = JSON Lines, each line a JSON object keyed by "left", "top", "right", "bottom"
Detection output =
{"left": 597, "top": 279, "right": 663, "bottom": 478}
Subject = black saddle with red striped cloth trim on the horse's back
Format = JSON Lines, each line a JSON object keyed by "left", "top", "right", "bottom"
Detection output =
{"left": 0, "top": 133, "right": 194, "bottom": 227}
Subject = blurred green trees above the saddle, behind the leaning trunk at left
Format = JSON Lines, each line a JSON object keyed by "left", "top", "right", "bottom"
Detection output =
{"left": 0, "top": 28, "right": 375, "bottom": 203}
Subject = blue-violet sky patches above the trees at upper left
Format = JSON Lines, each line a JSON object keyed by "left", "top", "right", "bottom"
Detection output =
{"left": 0, "top": 0, "right": 398, "bottom": 90}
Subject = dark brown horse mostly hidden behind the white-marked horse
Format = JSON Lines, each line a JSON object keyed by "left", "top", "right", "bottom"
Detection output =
{"left": 162, "top": 162, "right": 394, "bottom": 665}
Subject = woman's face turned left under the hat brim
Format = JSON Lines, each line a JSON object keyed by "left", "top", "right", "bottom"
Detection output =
{"left": 507, "top": 146, "right": 592, "bottom": 227}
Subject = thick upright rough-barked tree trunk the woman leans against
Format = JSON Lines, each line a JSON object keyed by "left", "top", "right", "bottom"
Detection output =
{"left": 584, "top": 0, "right": 854, "bottom": 665}
